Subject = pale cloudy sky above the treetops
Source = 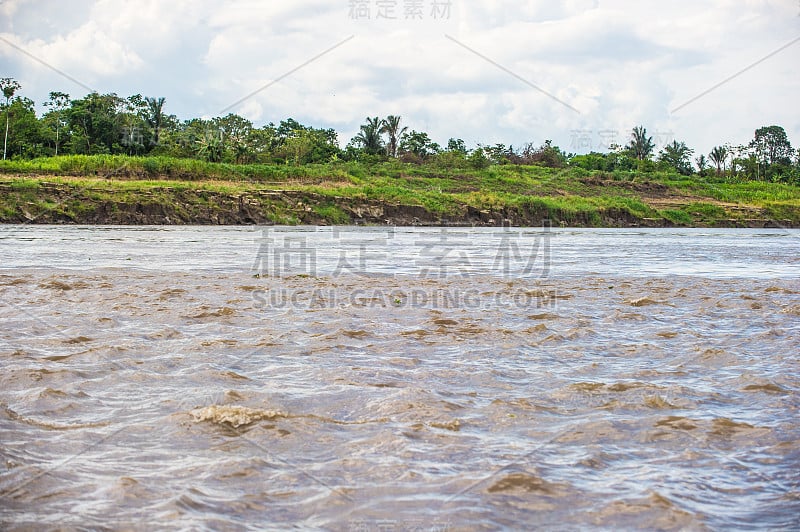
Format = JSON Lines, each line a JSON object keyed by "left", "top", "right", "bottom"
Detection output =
{"left": 0, "top": 0, "right": 800, "bottom": 153}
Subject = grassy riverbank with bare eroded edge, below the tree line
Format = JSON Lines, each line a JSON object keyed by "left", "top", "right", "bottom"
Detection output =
{"left": 0, "top": 157, "right": 800, "bottom": 228}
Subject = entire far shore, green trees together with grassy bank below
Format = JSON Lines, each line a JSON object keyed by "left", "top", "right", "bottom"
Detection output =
{"left": 0, "top": 78, "right": 800, "bottom": 226}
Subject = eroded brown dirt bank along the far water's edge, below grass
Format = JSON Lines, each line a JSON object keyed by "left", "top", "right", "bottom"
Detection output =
{"left": 0, "top": 181, "right": 792, "bottom": 228}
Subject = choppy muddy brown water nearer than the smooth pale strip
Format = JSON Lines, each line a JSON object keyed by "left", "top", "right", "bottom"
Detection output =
{"left": 0, "top": 269, "right": 800, "bottom": 529}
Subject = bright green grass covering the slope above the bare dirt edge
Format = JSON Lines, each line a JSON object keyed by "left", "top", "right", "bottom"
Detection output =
{"left": 0, "top": 155, "right": 800, "bottom": 226}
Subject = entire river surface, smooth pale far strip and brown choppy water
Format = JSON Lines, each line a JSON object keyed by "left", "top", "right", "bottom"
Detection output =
{"left": 0, "top": 226, "right": 800, "bottom": 530}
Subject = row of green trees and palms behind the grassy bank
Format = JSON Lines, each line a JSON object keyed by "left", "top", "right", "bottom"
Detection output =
{"left": 0, "top": 78, "right": 800, "bottom": 184}
